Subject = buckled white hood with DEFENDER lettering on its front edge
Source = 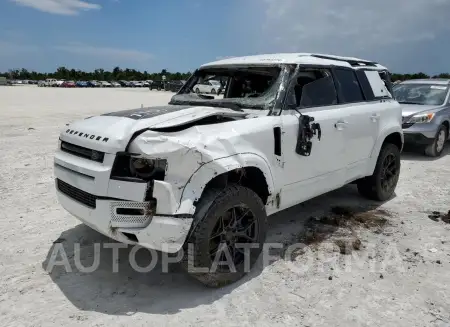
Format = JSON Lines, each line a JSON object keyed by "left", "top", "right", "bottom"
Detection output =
{"left": 60, "top": 105, "right": 247, "bottom": 153}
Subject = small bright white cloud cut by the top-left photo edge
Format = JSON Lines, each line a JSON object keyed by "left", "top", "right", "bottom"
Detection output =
{"left": 11, "top": 0, "right": 101, "bottom": 15}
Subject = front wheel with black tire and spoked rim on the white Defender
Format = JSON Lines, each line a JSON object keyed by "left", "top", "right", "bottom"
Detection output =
{"left": 182, "top": 185, "right": 267, "bottom": 288}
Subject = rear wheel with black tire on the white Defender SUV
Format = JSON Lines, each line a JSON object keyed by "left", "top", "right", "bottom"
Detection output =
{"left": 356, "top": 143, "right": 401, "bottom": 201}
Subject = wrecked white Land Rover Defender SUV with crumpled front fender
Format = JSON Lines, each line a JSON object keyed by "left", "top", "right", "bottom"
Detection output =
{"left": 54, "top": 53, "right": 403, "bottom": 286}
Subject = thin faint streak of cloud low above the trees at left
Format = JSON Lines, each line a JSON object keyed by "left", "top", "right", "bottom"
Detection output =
{"left": 54, "top": 42, "right": 153, "bottom": 61}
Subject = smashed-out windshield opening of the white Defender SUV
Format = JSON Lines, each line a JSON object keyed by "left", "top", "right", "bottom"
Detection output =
{"left": 170, "top": 65, "right": 283, "bottom": 110}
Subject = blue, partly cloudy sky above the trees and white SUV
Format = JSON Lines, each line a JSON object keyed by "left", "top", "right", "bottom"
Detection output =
{"left": 0, "top": 0, "right": 450, "bottom": 74}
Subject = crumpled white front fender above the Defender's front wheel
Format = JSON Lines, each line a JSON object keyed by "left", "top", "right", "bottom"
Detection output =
{"left": 129, "top": 126, "right": 274, "bottom": 215}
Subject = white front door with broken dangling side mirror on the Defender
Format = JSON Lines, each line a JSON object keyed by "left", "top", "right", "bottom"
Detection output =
{"left": 280, "top": 69, "right": 348, "bottom": 209}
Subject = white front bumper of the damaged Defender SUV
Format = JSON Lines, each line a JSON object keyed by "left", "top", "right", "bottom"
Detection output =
{"left": 54, "top": 150, "right": 193, "bottom": 253}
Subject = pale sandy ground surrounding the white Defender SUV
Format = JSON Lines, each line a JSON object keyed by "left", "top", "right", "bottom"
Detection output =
{"left": 0, "top": 87, "right": 450, "bottom": 327}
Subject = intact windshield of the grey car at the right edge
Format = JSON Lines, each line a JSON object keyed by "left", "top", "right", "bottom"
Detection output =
{"left": 394, "top": 83, "right": 448, "bottom": 105}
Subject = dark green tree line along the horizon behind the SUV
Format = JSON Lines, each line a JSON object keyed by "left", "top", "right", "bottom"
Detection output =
{"left": 0, "top": 67, "right": 450, "bottom": 82}
